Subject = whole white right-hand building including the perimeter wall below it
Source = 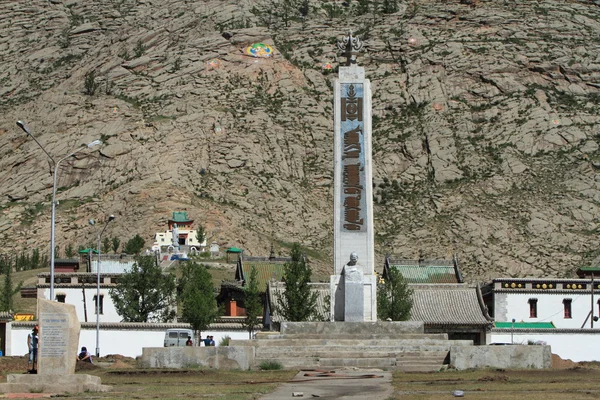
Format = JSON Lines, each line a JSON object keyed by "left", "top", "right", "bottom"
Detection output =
{"left": 482, "top": 267, "right": 600, "bottom": 362}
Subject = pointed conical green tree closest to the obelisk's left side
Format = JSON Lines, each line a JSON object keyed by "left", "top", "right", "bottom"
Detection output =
{"left": 277, "top": 243, "right": 321, "bottom": 321}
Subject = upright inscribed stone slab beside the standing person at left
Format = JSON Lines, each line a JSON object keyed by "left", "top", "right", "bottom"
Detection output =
{"left": 38, "top": 299, "right": 80, "bottom": 375}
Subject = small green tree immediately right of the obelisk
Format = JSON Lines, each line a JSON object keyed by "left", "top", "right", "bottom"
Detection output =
{"left": 377, "top": 268, "right": 413, "bottom": 321}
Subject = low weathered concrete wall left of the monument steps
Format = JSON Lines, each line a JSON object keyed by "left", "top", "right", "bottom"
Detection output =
{"left": 141, "top": 346, "right": 254, "bottom": 370}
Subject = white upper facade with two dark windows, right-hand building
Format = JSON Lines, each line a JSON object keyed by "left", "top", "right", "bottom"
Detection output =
{"left": 494, "top": 291, "right": 600, "bottom": 329}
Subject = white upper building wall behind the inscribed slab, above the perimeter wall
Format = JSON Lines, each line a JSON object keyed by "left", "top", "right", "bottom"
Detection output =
{"left": 38, "top": 286, "right": 122, "bottom": 323}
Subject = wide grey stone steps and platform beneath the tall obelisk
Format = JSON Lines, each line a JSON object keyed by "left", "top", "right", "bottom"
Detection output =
{"left": 248, "top": 322, "right": 473, "bottom": 372}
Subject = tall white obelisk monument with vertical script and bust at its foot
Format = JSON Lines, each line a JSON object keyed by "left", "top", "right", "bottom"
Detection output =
{"left": 330, "top": 33, "right": 377, "bottom": 321}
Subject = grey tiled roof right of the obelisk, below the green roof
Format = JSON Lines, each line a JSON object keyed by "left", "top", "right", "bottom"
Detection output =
{"left": 410, "top": 285, "right": 492, "bottom": 325}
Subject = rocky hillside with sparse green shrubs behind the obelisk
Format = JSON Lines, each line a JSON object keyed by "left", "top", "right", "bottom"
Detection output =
{"left": 0, "top": 0, "right": 600, "bottom": 281}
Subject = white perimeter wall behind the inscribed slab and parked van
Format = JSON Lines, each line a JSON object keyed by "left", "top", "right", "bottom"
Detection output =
{"left": 6, "top": 325, "right": 248, "bottom": 358}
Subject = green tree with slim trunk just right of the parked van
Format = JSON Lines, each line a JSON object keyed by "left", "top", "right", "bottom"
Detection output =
{"left": 181, "top": 262, "right": 219, "bottom": 343}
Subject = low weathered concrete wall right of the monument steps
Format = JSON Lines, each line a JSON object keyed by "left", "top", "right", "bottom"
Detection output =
{"left": 450, "top": 345, "right": 552, "bottom": 370}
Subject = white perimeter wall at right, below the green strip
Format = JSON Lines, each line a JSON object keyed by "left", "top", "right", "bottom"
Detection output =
{"left": 491, "top": 330, "right": 600, "bottom": 362}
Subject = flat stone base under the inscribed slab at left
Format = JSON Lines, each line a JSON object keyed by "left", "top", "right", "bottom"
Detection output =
{"left": 0, "top": 374, "right": 112, "bottom": 394}
